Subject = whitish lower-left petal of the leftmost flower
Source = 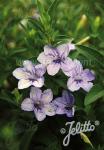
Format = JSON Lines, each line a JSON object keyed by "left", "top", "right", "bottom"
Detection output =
{"left": 18, "top": 79, "right": 32, "bottom": 89}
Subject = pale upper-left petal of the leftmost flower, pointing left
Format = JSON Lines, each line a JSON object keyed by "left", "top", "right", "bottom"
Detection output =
{"left": 13, "top": 68, "right": 29, "bottom": 79}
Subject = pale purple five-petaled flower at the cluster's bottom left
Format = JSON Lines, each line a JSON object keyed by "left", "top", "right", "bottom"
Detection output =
{"left": 21, "top": 87, "right": 55, "bottom": 121}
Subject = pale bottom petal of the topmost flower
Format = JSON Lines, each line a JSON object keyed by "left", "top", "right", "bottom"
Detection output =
{"left": 47, "top": 63, "right": 60, "bottom": 76}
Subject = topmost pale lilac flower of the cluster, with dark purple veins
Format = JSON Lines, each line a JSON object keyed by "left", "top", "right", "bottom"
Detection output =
{"left": 37, "top": 43, "right": 75, "bottom": 76}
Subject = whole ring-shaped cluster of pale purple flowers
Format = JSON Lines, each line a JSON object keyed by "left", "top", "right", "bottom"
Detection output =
{"left": 13, "top": 43, "right": 95, "bottom": 121}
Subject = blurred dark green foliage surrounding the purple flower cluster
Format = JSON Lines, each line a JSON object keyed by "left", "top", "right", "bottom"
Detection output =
{"left": 0, "top": 0, "right": 104, "bottom": 150}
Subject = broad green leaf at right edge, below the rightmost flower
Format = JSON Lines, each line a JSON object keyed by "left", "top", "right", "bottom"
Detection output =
{"left": 84, "top": 84, "right": 104, "bottom": 106}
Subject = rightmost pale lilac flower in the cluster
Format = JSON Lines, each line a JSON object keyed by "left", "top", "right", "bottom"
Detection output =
{"left": 66, "top": 60, "right": 95, "bottom": 92}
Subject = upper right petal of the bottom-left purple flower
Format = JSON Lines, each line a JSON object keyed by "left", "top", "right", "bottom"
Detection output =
{"left": 41, "top": 89, "right": 53, "bottom": 104}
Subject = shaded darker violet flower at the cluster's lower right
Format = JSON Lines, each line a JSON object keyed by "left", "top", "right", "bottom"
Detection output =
{"left": 53, "top": 90, "right": 74, "bottom": 117}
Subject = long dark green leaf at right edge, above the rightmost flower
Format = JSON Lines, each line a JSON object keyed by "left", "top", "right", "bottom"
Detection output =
{"left": 77, "top": 45, "right": 104, "bottom": 68}
